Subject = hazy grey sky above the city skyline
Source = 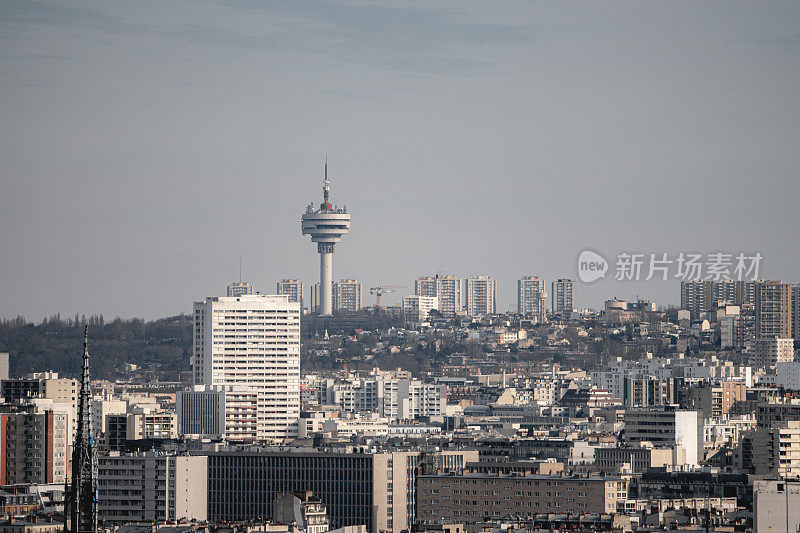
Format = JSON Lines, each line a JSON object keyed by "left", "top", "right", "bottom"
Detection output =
{"left": 0, "top": 0, "right": 800, "bottom": 321}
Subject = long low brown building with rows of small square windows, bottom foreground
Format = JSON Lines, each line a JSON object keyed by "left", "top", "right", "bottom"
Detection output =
{"left": 417, "top": 473, "right": 627, "bottom": 524}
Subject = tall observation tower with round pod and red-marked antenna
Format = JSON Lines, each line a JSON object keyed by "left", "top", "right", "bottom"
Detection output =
{"left": 301, "top": 161, "right": 350, "bottom": 315}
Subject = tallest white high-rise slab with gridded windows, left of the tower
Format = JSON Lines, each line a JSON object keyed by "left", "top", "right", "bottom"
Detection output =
{"left": 193, "top": 294, "right": 300, "bottom": 440}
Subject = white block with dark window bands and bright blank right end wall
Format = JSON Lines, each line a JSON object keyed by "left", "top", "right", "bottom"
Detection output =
{"left": 624, "top": 408, "right": 703, "bottom": 465}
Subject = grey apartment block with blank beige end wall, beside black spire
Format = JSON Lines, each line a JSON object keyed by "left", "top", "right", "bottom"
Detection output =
{"left": 97, "top": 452, "right": 208, "bottom": 525}
